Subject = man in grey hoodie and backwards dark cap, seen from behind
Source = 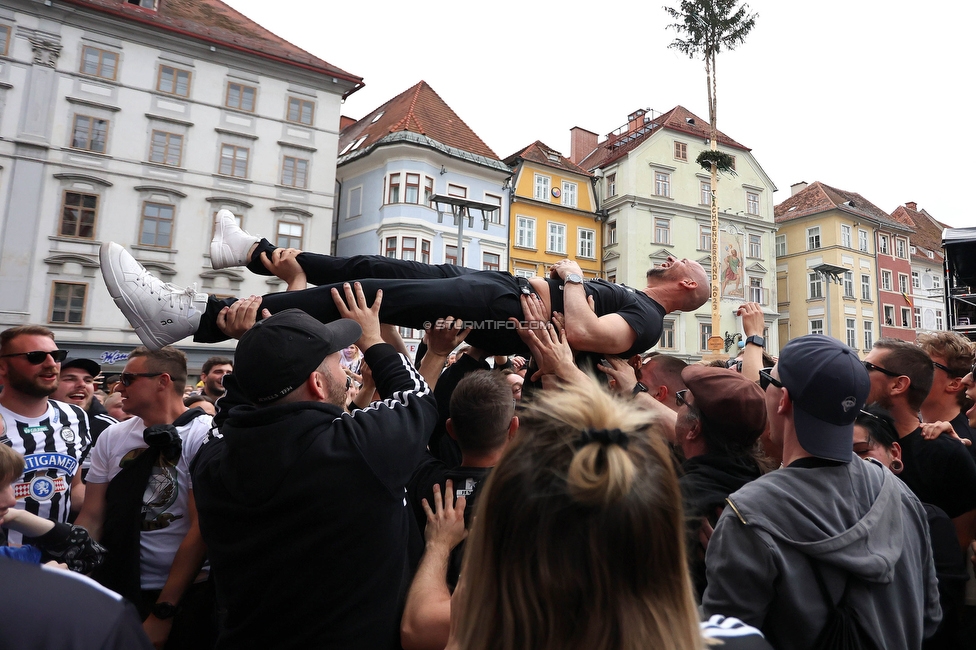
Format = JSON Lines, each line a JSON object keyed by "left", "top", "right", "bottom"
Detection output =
{"left": 702, "top": 335, "right": 942, "bottom": 648}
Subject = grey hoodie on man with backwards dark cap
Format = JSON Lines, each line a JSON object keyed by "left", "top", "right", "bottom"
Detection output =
{"left": 702, "top": 456, "right": 942, "bottom": 650}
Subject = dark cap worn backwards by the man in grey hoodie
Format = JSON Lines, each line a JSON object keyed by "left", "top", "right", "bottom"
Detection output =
{"left": 776, "top": 334, "right": 871, "bottom": 463}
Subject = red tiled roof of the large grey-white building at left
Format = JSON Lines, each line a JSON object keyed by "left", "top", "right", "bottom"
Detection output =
{"left": 59, "top": 0, "right": 363, "bottom": 94}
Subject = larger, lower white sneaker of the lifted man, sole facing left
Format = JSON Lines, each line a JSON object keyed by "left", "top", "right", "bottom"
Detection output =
{"left": 98, "top": 242, "right": 207, "bottom": 350}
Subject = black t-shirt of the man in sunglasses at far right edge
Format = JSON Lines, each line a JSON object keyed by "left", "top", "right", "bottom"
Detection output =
{"left": 898, "top": 427, "right": 976, "bottom": 519}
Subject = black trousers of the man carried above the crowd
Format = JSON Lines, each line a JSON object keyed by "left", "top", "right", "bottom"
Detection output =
{"left": 193, "top": 239, "right": 530, "bottom": 354}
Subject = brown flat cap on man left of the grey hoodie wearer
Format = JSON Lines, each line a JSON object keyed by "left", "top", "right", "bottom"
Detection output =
{"left": 681, "top": 365, "right": 766, "bottom": 447}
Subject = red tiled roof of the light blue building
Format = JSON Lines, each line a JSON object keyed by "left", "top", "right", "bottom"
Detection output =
{"left": 339, "top": 81, "right": 498, "bottom": 160}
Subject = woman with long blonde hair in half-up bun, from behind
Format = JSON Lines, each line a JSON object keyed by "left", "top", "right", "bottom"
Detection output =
{"left": 448, "top": 374, "right": 769, "bottom": 650}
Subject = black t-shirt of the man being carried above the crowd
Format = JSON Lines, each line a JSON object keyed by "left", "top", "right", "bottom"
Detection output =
{"left": 549, "top": 278, "right": 666, "bottom": 357}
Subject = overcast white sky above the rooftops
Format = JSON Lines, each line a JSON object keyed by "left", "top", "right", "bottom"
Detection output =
{"left": 225, "top": 0, "right": 976, "bottom": 227}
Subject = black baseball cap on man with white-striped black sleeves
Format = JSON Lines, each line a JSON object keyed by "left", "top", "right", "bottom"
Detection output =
{"left": 234, "top": 309, "right": 363, "bottom": 404}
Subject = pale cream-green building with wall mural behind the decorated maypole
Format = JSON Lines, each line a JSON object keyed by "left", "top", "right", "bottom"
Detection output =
{"left": 570, "top": 106, "right": 779, "bottom": 360}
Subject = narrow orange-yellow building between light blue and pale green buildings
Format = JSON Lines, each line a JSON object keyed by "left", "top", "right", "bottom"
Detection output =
{"left": 505, "top": 141, "right": 603, "bottom": 278}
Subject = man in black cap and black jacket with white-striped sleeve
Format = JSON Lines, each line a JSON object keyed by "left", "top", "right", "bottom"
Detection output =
{"left": 193, "top": 283, "right": 437, "bottom": 650}
